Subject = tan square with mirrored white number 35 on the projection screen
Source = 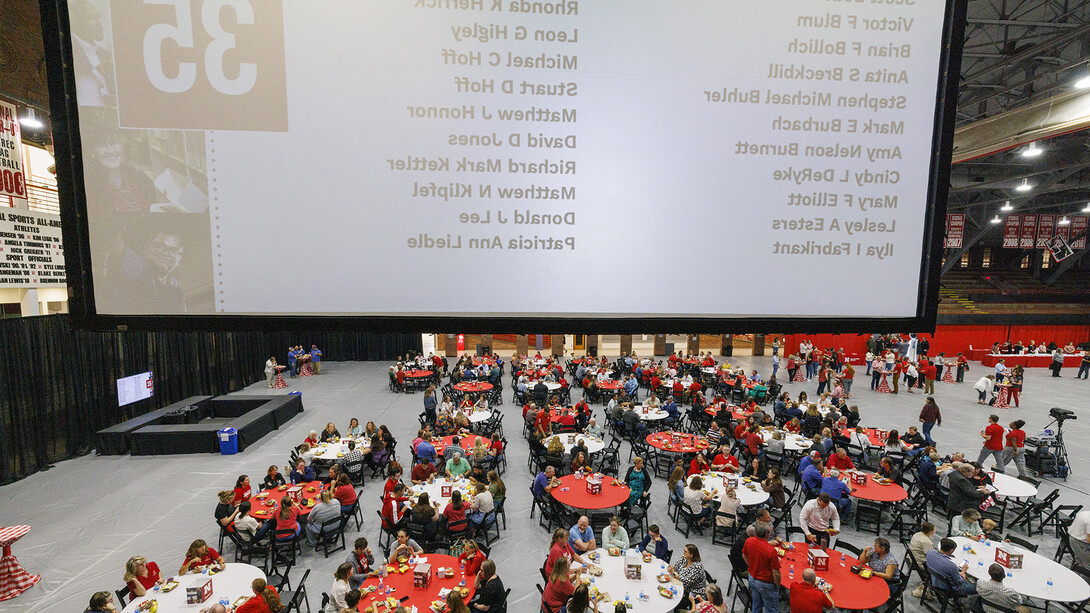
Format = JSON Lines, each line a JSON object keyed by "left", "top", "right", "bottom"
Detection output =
{"left": 110, "top": 0, "right": 288, "bottom": 132}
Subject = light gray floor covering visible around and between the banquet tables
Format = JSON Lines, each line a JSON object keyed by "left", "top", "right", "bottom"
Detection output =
{"left": 0, "top": 357, "right": 1090, "bottom": 612}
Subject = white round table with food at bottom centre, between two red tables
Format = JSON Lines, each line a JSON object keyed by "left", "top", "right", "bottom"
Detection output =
{"left": 581, "top": 549, "right": 685, "bottom": 613}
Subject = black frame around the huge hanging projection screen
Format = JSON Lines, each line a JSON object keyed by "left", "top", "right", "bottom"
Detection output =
{"left": 39, "top": 0, "right": 968, "bottom": 334}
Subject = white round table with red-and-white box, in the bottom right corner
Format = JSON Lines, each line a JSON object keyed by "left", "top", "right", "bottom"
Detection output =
{"left": 954, "top": 537, "right": 1090, "bottom": 605}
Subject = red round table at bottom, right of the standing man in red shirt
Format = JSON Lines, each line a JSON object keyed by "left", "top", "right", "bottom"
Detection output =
{"left": 779, "top": 542, "right": 889, "bottom": 611}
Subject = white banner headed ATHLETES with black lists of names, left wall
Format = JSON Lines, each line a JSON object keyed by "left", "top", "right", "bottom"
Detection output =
{"left": 0, "top": 209, "right": 65, "bottom": 288}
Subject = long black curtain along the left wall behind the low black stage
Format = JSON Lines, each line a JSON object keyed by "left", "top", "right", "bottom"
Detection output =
{"left": 0, "top": 315, "right": 422, "bottom": 483}
